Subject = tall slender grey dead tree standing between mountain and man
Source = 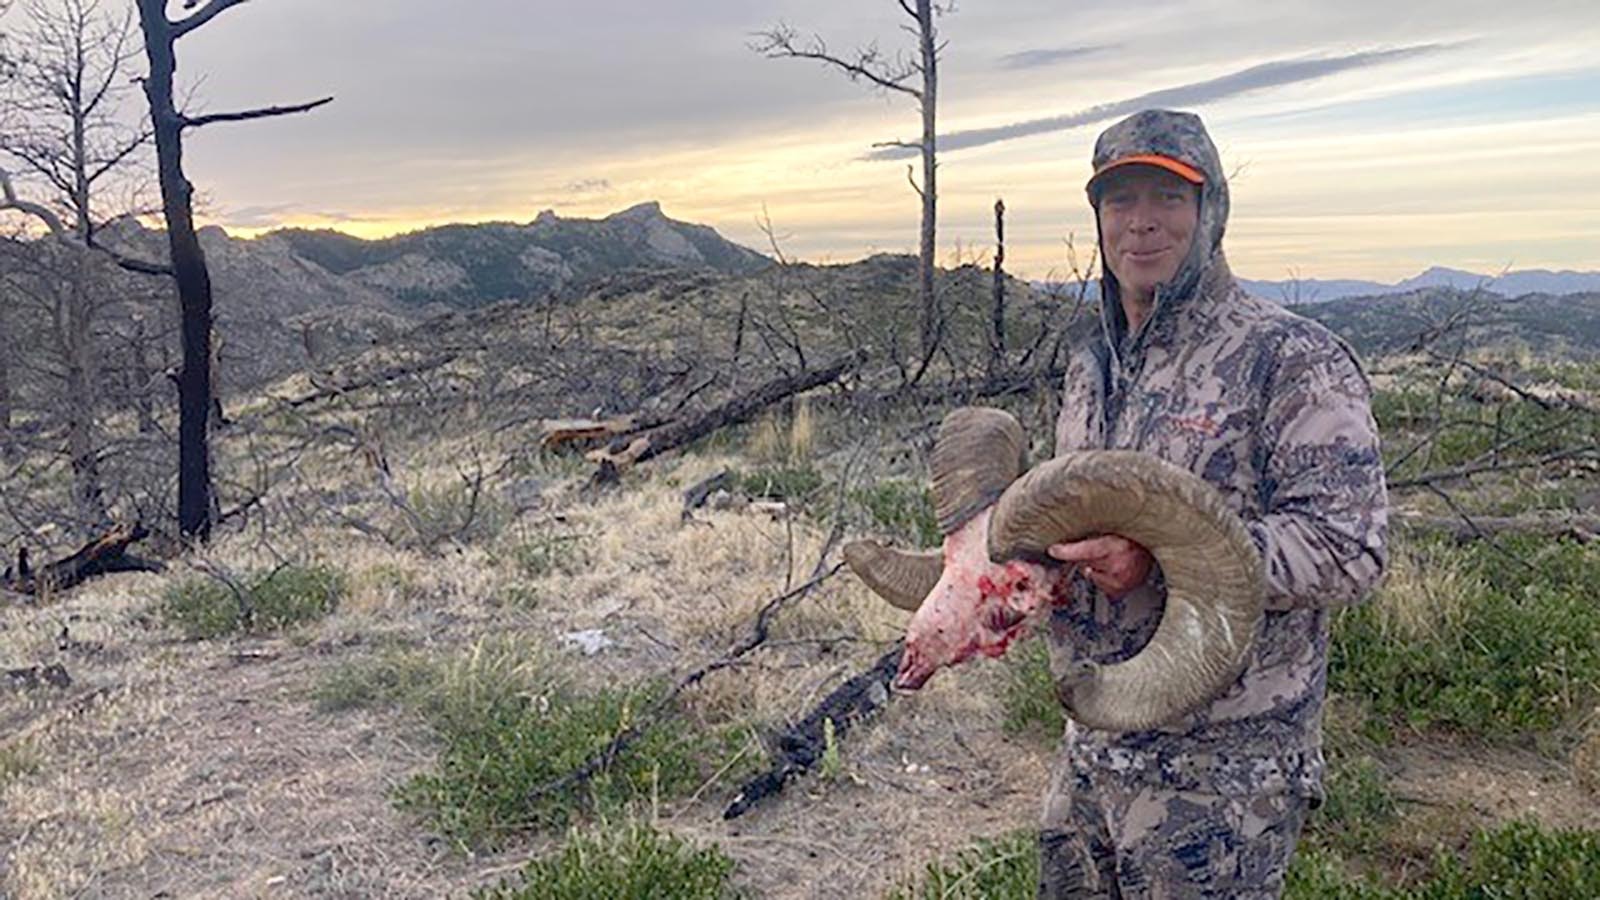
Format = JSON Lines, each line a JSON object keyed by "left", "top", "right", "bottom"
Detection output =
{"left": 750, "top": 0, "right": 954, "bottom": 368}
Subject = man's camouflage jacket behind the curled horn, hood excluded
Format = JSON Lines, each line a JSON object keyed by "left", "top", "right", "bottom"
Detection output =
{"left": 1050, "top": 248, "right": 1387, "bottom": 796}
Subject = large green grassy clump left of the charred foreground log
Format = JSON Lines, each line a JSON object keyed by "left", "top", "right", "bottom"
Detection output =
{"left": 317, "top": 641, "right": 758, "bottom": 849}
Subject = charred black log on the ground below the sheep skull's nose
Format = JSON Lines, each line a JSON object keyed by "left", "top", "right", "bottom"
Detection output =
{"left": 722, "top": 645, "right": 906, "bottom": 818}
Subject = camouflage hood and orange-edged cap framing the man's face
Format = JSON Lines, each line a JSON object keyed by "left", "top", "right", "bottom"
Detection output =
{"left": 1088, "top": 109, "right": 1227, "bottom": 335}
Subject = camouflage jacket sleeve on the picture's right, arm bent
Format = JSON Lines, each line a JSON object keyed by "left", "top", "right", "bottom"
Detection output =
{"left": 1248, "top": 328, "right": 1389, "bottom": 610}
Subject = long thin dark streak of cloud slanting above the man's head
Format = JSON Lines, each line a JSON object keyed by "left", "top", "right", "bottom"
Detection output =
{"left": 864, "top": 43, "right": 1450, "bottom": 160}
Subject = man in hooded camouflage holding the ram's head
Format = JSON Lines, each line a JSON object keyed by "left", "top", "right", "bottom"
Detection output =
{"left": 1040, "top": 110, "right": 1387, "bottom": 898}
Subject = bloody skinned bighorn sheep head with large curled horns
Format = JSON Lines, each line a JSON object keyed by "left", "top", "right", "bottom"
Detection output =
{"left": 845, "top": 407, "right": 1264, "bottom": 730}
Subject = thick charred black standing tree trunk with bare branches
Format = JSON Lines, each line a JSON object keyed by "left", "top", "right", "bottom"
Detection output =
{"left": 138, "top": 0, "right": 333, "bottom": 541}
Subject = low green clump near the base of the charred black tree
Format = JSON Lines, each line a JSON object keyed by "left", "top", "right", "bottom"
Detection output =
{"left": 160, "top": 565, "right": 347, "bottom": 639}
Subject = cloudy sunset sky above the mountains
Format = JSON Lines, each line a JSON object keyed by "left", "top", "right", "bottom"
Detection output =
{"left": 18, "top": 0, "right": 1600, "bottom": 280}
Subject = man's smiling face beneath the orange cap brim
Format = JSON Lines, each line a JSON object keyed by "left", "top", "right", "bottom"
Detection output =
{"left": 1099, "top": 165, "right": 1200, "bottom": 301}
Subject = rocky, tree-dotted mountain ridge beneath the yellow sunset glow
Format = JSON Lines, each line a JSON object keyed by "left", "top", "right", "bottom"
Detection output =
{"left": 266, "top": 202, "right": 768, "bottom": 309}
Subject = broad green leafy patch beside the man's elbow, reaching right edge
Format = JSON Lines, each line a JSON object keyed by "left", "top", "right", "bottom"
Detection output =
{"left": 1328, "top": 538, "right": 1600, "bottom": 738}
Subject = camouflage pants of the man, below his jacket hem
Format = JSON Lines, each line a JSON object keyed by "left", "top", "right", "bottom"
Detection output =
{"left": 1038, "top": 764, "right": 1310, "bottom": 900}
